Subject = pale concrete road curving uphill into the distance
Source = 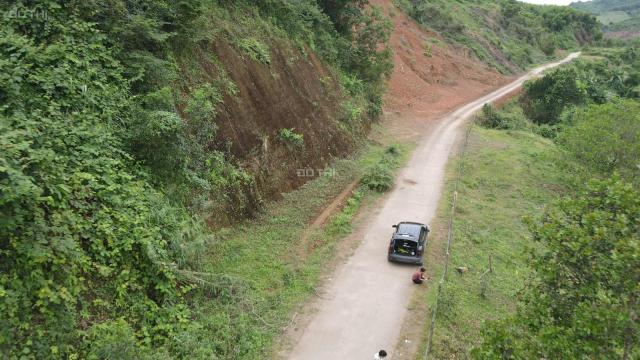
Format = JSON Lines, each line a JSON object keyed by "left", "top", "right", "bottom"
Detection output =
{"left": 288, "top": 53, "right": 580, "bottom": 360}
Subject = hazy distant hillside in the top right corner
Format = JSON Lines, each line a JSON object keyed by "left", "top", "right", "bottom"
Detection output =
{"left": 570, "top": 0, "right": 640, "bottom": 38}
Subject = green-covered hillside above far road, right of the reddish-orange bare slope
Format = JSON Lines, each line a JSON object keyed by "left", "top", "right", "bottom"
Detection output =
{"left": 397, "top": 0, "right": 601, "bottom": 72}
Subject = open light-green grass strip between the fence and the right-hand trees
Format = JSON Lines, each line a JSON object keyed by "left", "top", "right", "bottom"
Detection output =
{"left": 419, "top": 126, "right": 563, "bottom": 359}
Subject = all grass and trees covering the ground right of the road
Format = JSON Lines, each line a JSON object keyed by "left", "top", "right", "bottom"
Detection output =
{"left": 419, "top": 46, "right": 640, "bottom": 360}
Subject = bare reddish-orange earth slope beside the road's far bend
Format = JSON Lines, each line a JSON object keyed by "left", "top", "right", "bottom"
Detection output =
{"left": 371, "top": 0, "right": 508, "bottom": 120}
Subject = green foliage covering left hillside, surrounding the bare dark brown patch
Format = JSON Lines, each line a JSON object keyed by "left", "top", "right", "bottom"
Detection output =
{"left": 0, "top": 0, "right": 391, "bottom": 359}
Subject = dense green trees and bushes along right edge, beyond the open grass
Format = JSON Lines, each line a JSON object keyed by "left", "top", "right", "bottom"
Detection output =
{"left": 475, "top": 46, "right": 640, "bottom": 359}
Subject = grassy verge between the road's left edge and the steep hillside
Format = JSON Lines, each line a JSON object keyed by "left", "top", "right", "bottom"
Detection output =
{"left": 176, "top": 125, "right": 410, "bottom": 359}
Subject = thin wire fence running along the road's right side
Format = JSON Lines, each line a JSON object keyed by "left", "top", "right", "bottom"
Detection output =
{"left": 424, "top": 119, "right": 475, "bottom": 360}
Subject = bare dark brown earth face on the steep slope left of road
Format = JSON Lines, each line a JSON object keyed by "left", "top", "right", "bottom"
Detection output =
{"left": 185, "top": 33, "right": 356, "bottom": 215}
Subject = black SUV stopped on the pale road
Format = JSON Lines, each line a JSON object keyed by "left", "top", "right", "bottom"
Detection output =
{"left": 387, "top": 221, "right": 429, "bottom": 266}
